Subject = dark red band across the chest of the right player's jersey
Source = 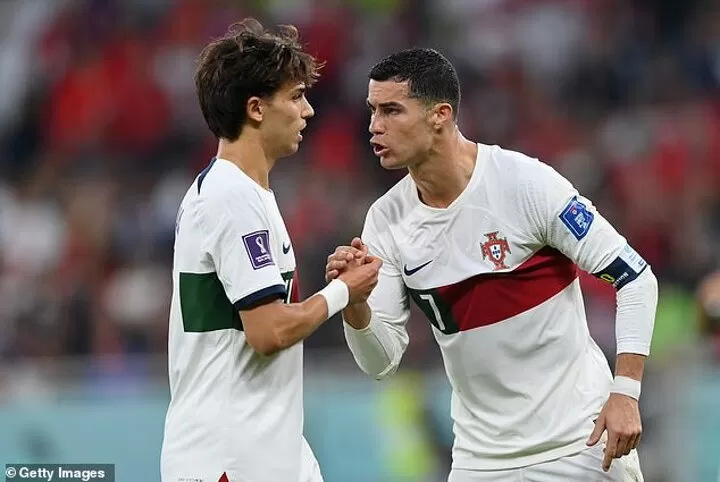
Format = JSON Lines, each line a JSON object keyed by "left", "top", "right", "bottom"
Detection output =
{"left": 437, "top": 247, "right": 578, "bottom": 331}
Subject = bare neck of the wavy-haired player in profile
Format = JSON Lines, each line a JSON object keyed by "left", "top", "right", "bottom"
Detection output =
{"left": 217, "top": 133, "right": 275, "bottom": 190}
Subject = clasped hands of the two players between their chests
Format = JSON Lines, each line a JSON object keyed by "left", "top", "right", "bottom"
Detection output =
{"left": 325, "top": 238, "right": 382, "bottom": 305}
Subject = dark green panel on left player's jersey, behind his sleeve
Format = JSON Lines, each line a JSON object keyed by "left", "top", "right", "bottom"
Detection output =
{"left": 180, "top": 273, "right": 242, "bottom": 333}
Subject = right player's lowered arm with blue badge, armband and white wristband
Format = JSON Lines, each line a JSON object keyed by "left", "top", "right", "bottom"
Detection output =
{"left": 527, "top": 161, "right": 658, "bottom": 471}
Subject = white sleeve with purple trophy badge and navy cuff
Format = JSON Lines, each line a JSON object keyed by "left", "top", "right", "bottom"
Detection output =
{"left": 200, "top": 186, "right": 286, "bottom": 310}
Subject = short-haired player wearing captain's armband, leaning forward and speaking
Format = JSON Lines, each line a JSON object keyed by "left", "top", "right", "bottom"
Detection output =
{"left": 326, "top": 49, "right": 657, "bottom": 482}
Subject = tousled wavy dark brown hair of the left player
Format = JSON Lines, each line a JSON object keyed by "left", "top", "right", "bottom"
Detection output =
{"left": 195, "top": 18, "right": 323, "bottom": 141}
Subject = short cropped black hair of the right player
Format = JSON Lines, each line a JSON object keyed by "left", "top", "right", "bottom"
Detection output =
{"left": 368, "top": 48, "right": 460, "bottom": 118}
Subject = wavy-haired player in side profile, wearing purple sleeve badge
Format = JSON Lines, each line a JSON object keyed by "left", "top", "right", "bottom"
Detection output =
{"left": 161, "top": 19, "right": 381, "bottom": 482}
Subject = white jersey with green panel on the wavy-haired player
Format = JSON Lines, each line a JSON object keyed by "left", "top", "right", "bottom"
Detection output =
{"left": 162, "top": 159, "right": 314, "bottom": 482}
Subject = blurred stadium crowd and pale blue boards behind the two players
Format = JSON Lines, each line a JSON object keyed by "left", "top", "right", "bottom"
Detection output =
{"left": 0, "top": 0, "right": 720, "bottom": 482}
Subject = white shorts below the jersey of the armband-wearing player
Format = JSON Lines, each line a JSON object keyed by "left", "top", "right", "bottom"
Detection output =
{"left": 448, "top": 444, "right": 644, "bottom": 482}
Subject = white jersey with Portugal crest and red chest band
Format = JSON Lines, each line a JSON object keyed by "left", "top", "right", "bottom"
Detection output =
{"left": 362, "top": 144, "right": 644, "bottom": 470}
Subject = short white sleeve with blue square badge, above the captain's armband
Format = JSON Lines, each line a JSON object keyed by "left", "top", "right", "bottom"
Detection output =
{"left": 524, "top": 161, "right": 627, "bottom": 275}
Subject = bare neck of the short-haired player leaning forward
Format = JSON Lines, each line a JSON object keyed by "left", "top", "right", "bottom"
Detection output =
{"left": 408, "top": 131, "right": 477, "bottom": 208}
